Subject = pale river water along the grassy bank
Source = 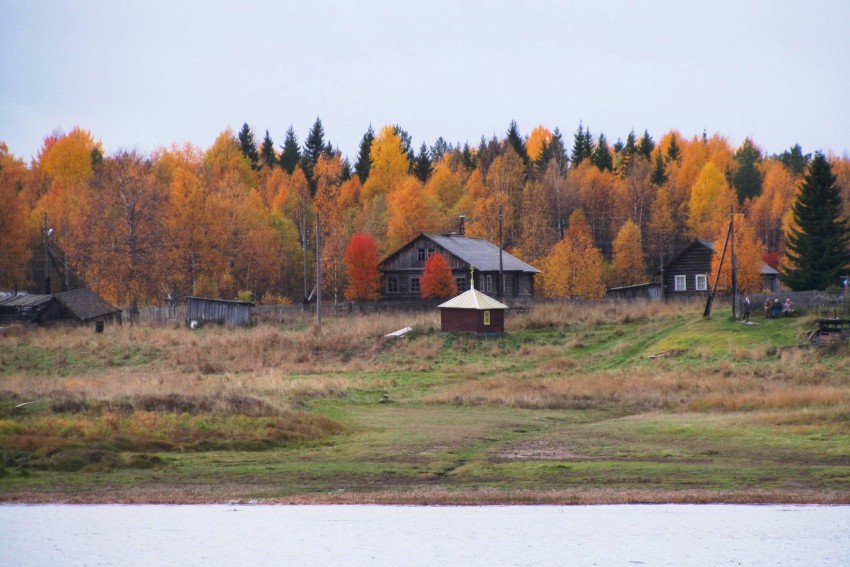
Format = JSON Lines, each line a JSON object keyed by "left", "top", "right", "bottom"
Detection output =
{"left": 0, "top": 505, "right": 850, "bottom": 567}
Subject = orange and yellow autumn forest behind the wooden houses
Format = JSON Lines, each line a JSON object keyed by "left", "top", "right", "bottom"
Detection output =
{"left": 0, "top": 119, "right": 850, "bottom": 306}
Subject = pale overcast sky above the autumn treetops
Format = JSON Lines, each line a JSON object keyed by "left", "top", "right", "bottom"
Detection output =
{"left": 0, "top": 0, "right": 850, "bottom": 161}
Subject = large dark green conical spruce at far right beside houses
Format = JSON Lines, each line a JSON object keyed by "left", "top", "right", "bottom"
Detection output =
{"left": 780, "top": 152, "right": 850, "bottom": 291}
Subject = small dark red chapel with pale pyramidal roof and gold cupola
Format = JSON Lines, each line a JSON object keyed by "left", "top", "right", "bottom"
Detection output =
{"left": 439, "top": 287, "right": 508, "bottom": 335}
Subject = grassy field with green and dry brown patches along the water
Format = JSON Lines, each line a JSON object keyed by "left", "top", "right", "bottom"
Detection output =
{"left": 0, "top": 304, "right": 850, "bottom": 504}
